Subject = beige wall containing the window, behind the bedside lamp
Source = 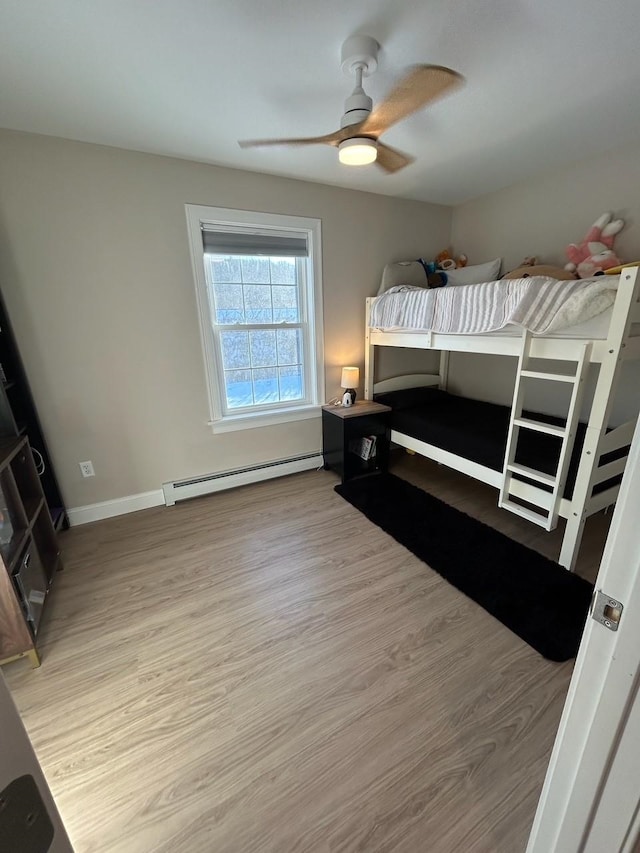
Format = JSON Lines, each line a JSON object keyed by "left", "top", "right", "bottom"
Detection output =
{"left": 0, "top": 131, "right": 451, "bottom": 507}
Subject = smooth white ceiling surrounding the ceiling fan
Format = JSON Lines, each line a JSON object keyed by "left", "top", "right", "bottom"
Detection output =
{"left": 0, "top": 0, "right": 640, "bottom": 204}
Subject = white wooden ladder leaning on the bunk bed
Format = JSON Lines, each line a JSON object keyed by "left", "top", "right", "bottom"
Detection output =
{"left": 498, "top": 329, "right": 591, "bottom": 530}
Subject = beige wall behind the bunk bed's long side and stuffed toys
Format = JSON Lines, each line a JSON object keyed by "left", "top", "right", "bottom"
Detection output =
{"left": 450, "top": 143, "right": 640, "bottom": 423}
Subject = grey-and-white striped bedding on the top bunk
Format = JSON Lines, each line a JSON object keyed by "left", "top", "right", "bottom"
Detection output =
{"left": 370, "top": 275, "right": 619, "bottom": 335}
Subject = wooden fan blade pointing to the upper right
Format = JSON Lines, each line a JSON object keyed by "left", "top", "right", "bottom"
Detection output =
{"left": 361, "top": 65, "right": 464, "bottom": 137}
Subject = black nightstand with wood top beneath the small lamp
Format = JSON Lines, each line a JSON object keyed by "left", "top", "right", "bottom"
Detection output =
{"left": 322, "top": 400, "right": 391, "bottom": 483}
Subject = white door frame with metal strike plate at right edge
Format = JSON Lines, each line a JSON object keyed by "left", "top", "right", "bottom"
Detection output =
{"left": 527, "top": 424, "right": 640, "bottom": 853}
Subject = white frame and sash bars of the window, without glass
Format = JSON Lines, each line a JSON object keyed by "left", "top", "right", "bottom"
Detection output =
{"left": 185, "top": 204, "right": 324, "bottom": 433}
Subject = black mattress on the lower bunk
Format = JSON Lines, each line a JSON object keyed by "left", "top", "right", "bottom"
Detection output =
{"left": 375, "top": 388, "right": 622, "bottom": 499}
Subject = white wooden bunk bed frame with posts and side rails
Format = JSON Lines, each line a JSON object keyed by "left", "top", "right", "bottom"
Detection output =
{"left": 364, "top": 267, "right": 640, "bottom": 570}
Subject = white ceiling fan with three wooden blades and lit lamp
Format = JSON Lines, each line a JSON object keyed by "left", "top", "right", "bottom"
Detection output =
{"left": 238, "top": 36, "right": 464, "bottom": 174}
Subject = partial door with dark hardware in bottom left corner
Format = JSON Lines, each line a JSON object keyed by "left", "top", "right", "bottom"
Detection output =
{"left": 0, "top": 673, "right": 73, "bottom": 853}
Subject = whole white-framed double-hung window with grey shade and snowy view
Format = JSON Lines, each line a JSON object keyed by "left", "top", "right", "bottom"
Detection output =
{"left": 187, "top": 205, "right": 324, "bottom": 432}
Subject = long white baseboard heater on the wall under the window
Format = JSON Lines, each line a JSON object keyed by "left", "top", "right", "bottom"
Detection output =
{"left": 162, "top": 453, "right": 322, "bottom": 506}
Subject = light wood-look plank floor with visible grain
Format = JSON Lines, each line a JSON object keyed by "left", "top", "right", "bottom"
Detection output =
{"left": 4, "top": 457, "right": 606, "bottom": 853}
